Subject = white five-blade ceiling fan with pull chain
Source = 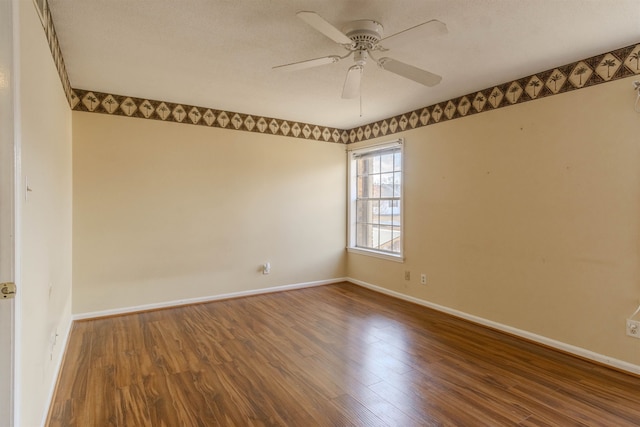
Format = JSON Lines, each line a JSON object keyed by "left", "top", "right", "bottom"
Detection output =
{"left": 273, "top": 11, "right": 447, "bottom": 99}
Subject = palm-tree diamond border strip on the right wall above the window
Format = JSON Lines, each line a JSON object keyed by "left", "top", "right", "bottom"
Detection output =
{"left": 347, "top": 44, "right": 640, "bottom": 144}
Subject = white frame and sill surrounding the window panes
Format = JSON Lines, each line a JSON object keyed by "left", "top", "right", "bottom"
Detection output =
{"left": 347, "top": 138, "right": 405, "bottom": 262}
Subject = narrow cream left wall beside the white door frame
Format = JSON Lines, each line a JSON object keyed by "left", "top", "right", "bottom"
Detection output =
{"left": 16, "top": 0, "right": 72, "bottom": 426}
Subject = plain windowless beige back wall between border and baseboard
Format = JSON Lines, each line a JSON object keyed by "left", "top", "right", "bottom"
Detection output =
{"left": 73, "top": 112, "right": 346, "bottom": 313}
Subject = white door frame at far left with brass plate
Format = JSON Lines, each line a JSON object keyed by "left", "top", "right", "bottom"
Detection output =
{"left": 0, "top": 0, "right": 20, "bottom": 427}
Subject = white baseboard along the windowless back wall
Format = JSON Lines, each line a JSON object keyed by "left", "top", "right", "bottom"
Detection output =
{"left": 72, "top": 277, "right": 347, "bottom": 321}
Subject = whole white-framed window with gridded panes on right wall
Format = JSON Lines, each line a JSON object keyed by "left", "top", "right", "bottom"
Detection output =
{"left": 349, "top": 140, "right": 402, "bottom": 260}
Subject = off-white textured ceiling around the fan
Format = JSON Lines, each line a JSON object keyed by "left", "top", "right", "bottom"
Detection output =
{"left": 49, "top": 0, "right": 640, "bottom": 129}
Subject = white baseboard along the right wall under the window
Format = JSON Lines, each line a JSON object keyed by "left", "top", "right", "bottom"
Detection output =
{"left": 347, "top": 277, "right": 640, "bottom": 375}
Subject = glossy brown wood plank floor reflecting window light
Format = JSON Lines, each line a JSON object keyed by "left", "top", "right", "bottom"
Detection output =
{"left": 48, "top": 283, "right": 640, "bottom": 427}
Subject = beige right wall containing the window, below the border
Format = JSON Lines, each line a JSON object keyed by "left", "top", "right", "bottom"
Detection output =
{"left": 348, "top": 79, "right": 640, "bottom": 365}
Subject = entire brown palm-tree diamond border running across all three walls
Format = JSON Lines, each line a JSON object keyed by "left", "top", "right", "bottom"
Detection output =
{"left": 34, "top": 0, "right": 640, "bottom": 144}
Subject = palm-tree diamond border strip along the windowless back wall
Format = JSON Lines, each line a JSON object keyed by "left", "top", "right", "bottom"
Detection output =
{"left": 71, "top": 89, "right": 349, "bottom": 144}
